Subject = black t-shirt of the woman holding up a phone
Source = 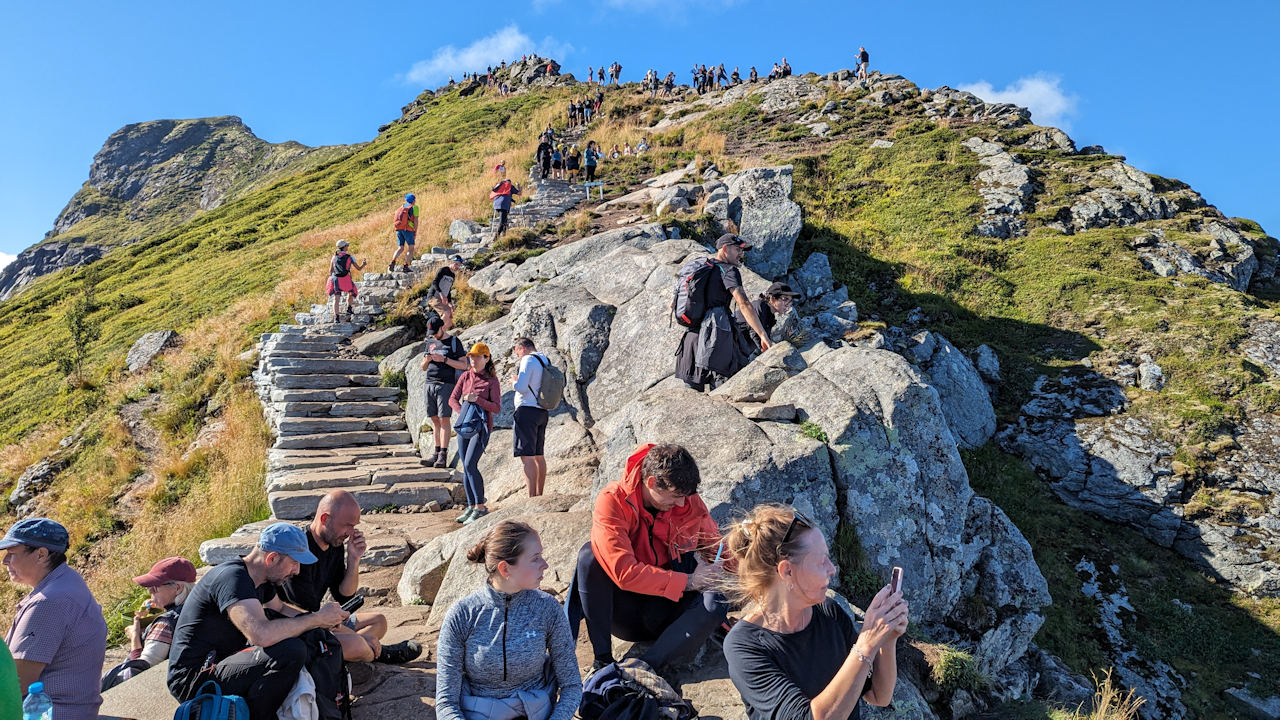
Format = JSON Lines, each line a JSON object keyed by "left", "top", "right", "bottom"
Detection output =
{"left": 724, "top": 598, "right": 870, "bottom": 720}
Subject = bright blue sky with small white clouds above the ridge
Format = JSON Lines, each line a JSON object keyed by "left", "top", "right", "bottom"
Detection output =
{"left": 0, "top": 0, "right": 1280, "bottom": 266}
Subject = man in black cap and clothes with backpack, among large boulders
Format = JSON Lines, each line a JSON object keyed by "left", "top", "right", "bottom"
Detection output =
{"left": 672, "top": 233, "right": 773, "bottom": 392}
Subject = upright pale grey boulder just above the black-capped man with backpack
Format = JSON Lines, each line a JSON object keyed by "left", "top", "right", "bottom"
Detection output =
{"left": 724, "top": 165, "right": 804, "bottom": 281}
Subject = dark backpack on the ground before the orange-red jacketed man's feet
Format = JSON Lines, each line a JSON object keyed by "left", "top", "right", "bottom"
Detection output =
{"left": 579, "top": 657, "right": 698, "bottom": 720}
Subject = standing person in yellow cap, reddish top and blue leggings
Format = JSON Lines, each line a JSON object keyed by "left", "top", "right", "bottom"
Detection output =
{"left": 449, "top": 342, "right": 502, "bottom": 525}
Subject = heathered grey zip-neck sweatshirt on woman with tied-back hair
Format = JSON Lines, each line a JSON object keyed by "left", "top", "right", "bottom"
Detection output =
{"left": 435, "top": 583, "right": 582, "bottom": 720}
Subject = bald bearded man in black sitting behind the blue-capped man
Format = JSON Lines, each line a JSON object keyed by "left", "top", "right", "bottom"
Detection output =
{"left": 280, "top": 489, "right": 422, "bottom": 664}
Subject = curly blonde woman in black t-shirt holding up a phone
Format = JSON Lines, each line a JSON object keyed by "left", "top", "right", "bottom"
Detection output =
{"left": 724, "top": 505, "right": 908, "bottom": 720}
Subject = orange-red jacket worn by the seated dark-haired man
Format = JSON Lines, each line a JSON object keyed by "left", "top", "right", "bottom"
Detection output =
{"left": 591, "top": 443, "right": 721, "bottom": 600}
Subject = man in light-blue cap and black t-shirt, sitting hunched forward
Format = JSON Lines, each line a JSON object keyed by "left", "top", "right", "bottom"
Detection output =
{"left": 169, "top": 523, "right": 347, "bottom": 720}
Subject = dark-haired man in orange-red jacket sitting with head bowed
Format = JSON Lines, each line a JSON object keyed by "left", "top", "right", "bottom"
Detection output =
{"left": 570, "top": 445, "right": 728, "bottom": 669}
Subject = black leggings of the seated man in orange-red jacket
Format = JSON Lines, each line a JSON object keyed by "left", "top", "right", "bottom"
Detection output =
{"left": 577, "top": 542, "right": 728, "bottom": 667}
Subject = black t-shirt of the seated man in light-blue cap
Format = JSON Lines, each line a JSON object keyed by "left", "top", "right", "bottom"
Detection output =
{"left": 169, "top": 559, "right": 275, "bottom": 697}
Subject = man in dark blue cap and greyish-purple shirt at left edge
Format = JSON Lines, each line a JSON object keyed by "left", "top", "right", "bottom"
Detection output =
{"left": 0, "top": 518, "right": 106, "bottom": 720}
